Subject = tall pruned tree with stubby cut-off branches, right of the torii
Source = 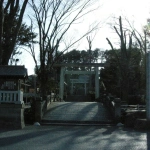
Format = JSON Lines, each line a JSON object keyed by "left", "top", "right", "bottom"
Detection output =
{"left": 107, "top": 17, "right": 143, "bottom": 101}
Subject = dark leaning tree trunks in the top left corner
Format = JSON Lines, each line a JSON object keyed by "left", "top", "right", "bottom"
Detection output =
{"left": 0, "top": 0, "right": 28, "bottom": 65}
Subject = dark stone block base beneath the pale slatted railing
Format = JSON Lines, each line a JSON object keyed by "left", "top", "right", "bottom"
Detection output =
{"left": 0, "top": 104, "right": 25, "bottom": 129}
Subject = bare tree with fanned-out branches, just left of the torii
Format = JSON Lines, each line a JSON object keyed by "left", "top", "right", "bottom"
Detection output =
{"left": 30, "top": 0, "right": 98, "bottom": 96}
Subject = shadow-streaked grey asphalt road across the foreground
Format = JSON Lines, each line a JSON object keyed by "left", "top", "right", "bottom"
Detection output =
{"left": 0, "top": 126, "right": 150, "bottom": 150}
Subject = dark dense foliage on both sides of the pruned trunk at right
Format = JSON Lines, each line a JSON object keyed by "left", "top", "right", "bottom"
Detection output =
{"left": 100, "top": 48, "right": 145, "bottom": 103}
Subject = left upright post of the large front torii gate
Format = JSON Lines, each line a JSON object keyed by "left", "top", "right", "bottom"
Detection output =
{"left": 59, "top": 67, "right": 65, "bottom": 99}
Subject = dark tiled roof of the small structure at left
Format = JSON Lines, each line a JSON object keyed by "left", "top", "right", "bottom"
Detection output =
{"left": 0, "top": 66, "right": 28, "bottom": 78}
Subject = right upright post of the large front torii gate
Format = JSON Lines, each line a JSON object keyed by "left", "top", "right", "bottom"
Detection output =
{"left": 95, "top": 67, "right": 99, "bottom": 98}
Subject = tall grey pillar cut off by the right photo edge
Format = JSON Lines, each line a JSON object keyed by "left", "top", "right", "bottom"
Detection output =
{"left": 146, "top": 52, "right": 150, "bottom": 121}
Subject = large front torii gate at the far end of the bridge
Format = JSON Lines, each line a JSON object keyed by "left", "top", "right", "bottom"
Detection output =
{"left": 54, "top": 63, "right": 107, "bottom": 99}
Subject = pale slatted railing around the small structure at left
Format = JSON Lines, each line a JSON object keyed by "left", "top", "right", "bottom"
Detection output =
{"left": 0, "top": 91, "right": 24, "bottom": 104}
